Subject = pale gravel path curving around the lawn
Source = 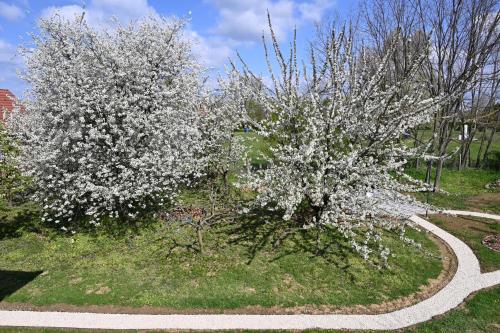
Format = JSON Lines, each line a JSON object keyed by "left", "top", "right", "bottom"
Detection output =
{"left": 0, "top": 211, "right": 500, "bottom": 330}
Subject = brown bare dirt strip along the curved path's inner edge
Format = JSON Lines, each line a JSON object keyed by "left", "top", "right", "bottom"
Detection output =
{"left": 0, "top": 234, "right": 457, "bottom": 314}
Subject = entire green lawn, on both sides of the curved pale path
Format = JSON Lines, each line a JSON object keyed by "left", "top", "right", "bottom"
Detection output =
{"left": 0, "top": 133, "right": 500, "bottom": 326}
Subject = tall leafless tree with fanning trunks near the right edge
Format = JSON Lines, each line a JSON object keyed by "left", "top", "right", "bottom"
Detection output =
{"left": 415, "top": 0, "right": 500, "bottom": 190}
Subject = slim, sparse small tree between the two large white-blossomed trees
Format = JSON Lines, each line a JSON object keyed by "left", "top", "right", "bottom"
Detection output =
{"left": 183, "top": 71, "right": 252, "bottom": 253}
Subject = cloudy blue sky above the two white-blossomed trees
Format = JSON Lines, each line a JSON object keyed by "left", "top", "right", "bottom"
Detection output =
{"left": 0, "top": 0, "right": 358, "bottom": 96}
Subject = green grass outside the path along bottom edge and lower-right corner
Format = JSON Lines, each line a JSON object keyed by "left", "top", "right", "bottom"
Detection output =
{"left": 0, "top": 287, "right": 500, "bottom": 333}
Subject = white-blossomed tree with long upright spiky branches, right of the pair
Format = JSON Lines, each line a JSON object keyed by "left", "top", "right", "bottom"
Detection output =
{"left": 236, "top": 18, "right": 448, "bottom": 261}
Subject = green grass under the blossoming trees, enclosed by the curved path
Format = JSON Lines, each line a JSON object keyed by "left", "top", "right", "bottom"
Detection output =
{"left": 0, "top": 215, "right": 441, "bottom": 310}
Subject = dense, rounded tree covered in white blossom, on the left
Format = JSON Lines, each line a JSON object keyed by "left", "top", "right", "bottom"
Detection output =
{"left": 10, "top": 15, "right": 203, "bottom": 224}
